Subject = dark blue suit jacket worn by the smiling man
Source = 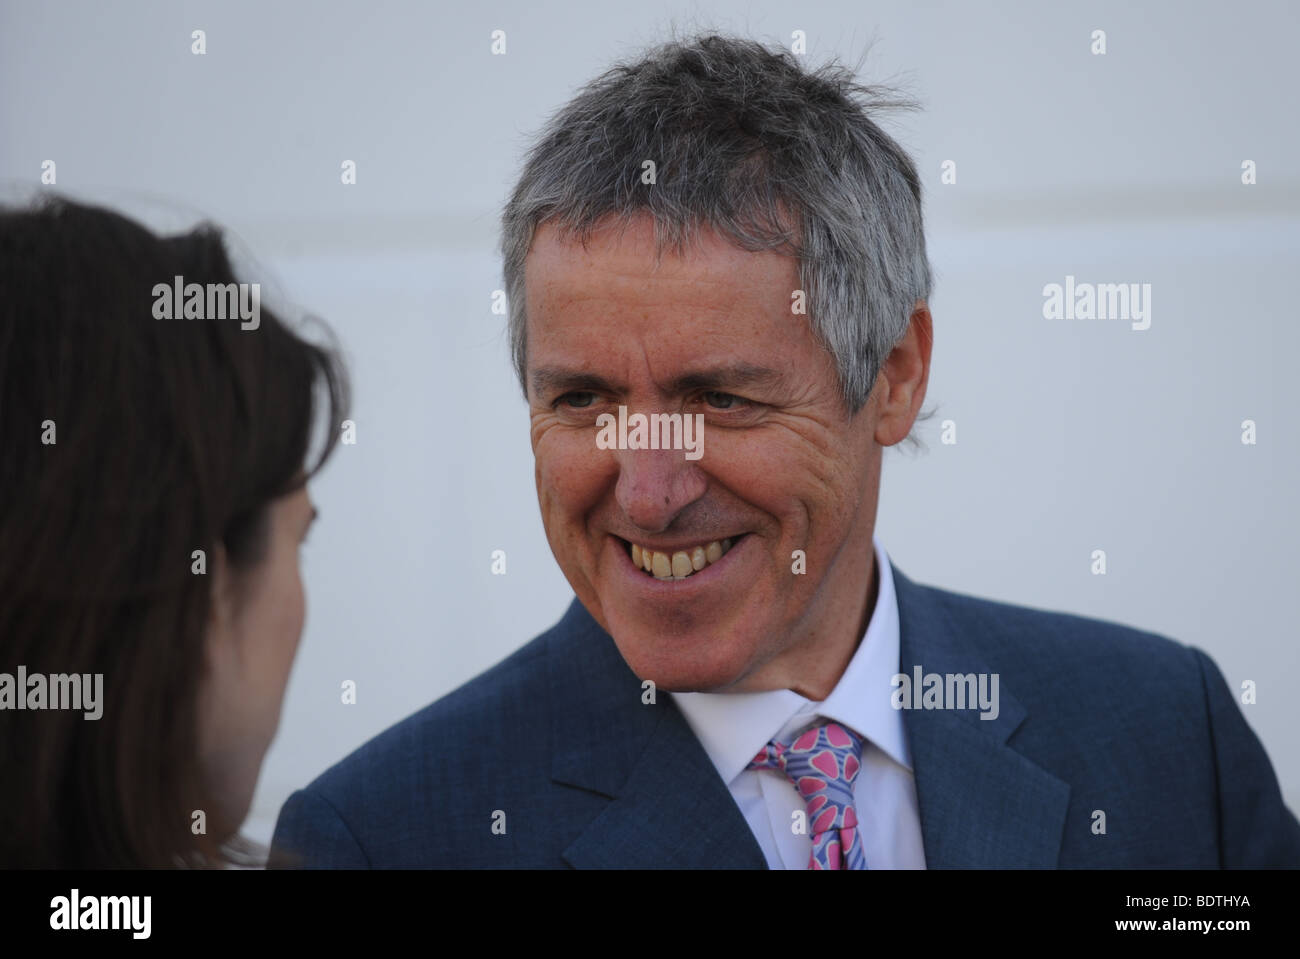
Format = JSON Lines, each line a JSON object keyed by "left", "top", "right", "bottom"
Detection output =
{"left": 270, "top": 568, "right": 1300, "bottom": 868}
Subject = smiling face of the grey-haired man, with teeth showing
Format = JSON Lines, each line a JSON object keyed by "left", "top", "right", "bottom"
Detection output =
{"left": 525, "top": 218, "right": 880, "bottom": 691}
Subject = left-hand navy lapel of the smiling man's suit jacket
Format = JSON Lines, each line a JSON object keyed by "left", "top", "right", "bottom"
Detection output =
{"left": 547, "top": 600, "right": 767, "bottom": 869}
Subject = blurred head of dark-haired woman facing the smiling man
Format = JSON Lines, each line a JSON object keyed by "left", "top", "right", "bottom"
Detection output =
{"left": 0, "top": 194, "right": 346, "bottom": 867}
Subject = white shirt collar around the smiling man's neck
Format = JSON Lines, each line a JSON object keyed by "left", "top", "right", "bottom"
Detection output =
{"left": 672, "top": 538, "right": 911, "bottom": 784}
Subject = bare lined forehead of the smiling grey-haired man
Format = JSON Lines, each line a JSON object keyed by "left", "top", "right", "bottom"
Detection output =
{"left": 524, "top": 217, "right": 807, "bottom": 366}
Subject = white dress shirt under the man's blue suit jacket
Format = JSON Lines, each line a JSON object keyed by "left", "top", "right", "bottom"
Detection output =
{"left": 672, "top": 538, "right": 926, "bottom": 869}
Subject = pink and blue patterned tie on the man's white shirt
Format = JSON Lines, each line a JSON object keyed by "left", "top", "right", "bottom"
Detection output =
{"left": 746, "top": 722, "right": 867, "bottom": 869}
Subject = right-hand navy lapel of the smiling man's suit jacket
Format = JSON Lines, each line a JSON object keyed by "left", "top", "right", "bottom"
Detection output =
{"left": 893, "top": 567, "right": 1070, "bottom": 868}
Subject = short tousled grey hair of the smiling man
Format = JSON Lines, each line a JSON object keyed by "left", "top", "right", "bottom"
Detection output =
{"left": 501, "top": 35, "right": 931, "bottom": 441}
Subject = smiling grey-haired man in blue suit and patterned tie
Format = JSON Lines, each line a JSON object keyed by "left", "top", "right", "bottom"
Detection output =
{"left": 273, "top": 36, "right": 1300, "bottom": 868}
